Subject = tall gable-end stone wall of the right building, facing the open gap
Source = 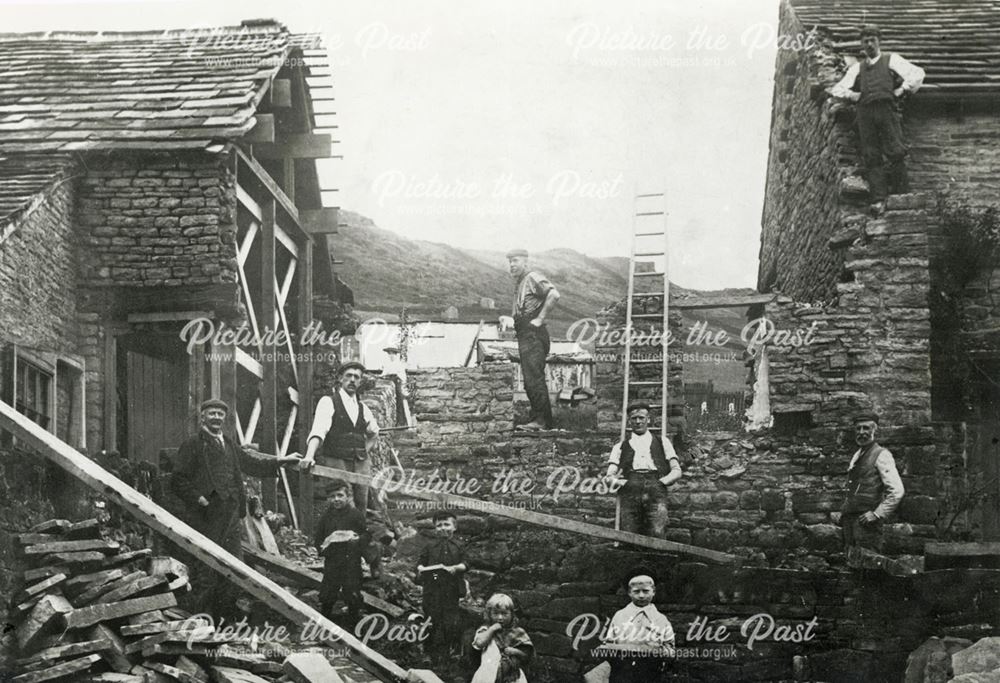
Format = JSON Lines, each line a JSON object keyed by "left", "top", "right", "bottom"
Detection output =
{"left": 757, "top": 3, "right": 854, "bottom": 301}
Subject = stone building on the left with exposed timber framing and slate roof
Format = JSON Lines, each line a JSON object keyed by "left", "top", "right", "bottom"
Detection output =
{"left": 0, "top": 21, "right": 349, "bottom": 524}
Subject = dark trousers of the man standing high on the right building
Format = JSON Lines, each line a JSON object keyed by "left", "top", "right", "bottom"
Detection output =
{"left": 857, "top": 100, "right": 909, "bottom": 202}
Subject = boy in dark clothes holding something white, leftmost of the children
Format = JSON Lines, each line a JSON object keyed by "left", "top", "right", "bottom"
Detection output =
{"left": 315, "top": 479, "right": 370, "bottom": 630}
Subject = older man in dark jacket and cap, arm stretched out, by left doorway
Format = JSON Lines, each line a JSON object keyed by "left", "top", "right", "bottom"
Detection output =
{"left": 171, "top": 398, "right": 299, "bottom": 616}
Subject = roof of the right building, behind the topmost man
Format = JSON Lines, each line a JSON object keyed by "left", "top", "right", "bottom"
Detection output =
{"left": 791, "top": 0, "right": 1000, "bottom": 96}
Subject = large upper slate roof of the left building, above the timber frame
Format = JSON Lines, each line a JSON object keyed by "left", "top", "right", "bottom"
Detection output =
{"left": 0, "top": 21, "right": 318, "bottom": 154}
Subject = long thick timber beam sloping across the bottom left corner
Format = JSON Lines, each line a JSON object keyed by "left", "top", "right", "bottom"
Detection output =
{"left": 0, "top": 401, "right": 407, "bottom": 681}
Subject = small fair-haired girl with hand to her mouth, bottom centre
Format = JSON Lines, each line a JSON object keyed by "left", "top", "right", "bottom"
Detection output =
{"left": 472, "top": 593, "right": 535, "bottom": 683}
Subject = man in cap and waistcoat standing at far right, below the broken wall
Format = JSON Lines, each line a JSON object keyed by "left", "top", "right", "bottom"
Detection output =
{"left": 840, "top": 413, "right": 904, "bottom": 551}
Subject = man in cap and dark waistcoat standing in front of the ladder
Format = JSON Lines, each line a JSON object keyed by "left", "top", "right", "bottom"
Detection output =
{"left": 605, "top": 401, "right": 682, "bottom": 537}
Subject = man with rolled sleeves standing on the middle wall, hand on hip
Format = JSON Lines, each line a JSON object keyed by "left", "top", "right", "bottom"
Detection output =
{"left": 507, "top": 249, "right": 559, "bottom": 431}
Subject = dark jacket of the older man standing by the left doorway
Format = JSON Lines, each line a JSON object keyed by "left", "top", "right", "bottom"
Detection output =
{"left": 171, "top": 429, "right": 279, "bottom": 517}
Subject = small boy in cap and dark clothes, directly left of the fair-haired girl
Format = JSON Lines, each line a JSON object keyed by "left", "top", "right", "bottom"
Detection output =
{"left": 417, "top": 510, "right": 468, "bottom": 654}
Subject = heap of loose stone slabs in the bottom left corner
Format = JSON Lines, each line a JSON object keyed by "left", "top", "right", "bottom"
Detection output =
{"left": 9, "top": 520, "right": 358, "bottom": 683}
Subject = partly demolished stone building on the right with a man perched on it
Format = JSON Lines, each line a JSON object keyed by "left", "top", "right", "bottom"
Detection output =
{"left": 753, "top": 0, "right": 1000, "bottom": 552}
